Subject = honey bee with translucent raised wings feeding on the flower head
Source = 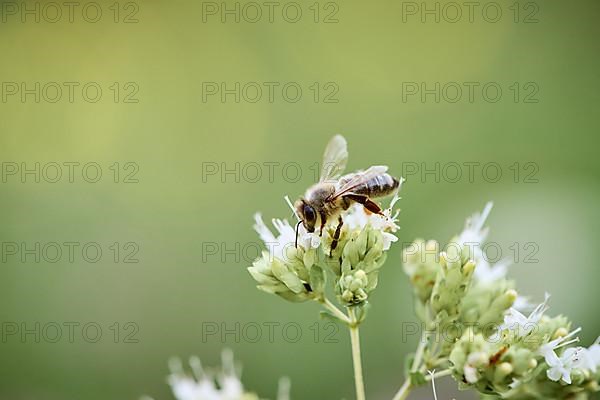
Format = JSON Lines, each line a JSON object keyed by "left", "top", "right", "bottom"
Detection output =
{"left": 294, "top": 135, "right": 400, "bottom": 250}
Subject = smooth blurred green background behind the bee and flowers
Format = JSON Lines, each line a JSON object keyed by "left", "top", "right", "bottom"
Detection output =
{"left": 0, "top": 0, "right": 600, "bottom": 400}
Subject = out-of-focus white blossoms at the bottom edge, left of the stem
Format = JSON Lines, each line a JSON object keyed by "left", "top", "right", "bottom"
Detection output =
{"left": 144, "top": 350, "right": 290, "bottom": 400}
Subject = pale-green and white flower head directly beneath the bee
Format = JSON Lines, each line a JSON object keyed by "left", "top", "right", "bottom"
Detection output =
{"left": 248, "top": 190, "right": 399, "bottom": 307}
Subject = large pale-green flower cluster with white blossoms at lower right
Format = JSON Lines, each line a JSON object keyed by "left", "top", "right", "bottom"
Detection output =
{"left": 404, "top": 203, "right": 600, "bottom": 399}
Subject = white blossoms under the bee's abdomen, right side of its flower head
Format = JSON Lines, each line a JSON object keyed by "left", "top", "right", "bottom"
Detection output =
{"left": 343, "top": 188, "right": 404, "bottom": 250}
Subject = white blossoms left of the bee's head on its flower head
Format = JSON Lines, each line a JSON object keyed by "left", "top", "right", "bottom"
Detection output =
{"left": 254, "top": 213, "right": 321, "bottom": 261}
